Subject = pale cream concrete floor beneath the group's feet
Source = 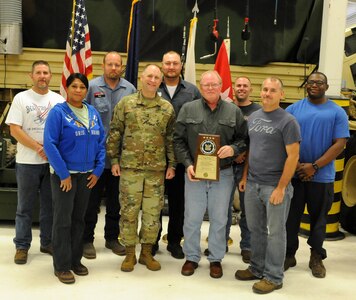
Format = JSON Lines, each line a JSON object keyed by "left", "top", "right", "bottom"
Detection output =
{"left": 0, "top": 208, "right": 356, "bottom": 300}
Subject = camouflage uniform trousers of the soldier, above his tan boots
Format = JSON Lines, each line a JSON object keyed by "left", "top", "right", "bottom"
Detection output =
{"left": 119, "top": 169, "right": 165, "bottom": 246}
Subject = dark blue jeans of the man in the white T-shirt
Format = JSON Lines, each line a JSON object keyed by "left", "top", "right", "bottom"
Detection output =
{"left": 14, "top": 163, "right": 53, "bottom": 249}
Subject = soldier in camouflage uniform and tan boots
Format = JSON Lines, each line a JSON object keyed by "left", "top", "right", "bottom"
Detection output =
{"left": 107, "top": 64, "right": 176, "bottom": 272}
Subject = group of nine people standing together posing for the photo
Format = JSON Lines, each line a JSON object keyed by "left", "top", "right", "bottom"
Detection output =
{"left": 6, "top": 51, "right": 349, "bottom": 294}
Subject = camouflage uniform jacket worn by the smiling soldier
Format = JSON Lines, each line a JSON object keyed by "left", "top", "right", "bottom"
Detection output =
{"left": 107, "top": 92, "right": 176, "bottom": 171}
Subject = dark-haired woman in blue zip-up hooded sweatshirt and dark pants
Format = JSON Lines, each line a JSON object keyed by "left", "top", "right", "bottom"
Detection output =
{"left": 44, "top": 73, "right": 105, "bottom": 283}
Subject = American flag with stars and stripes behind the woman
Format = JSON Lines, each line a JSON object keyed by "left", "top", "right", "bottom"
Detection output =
{"left": 60, "top": 0, "right": 93, "bottom": 99}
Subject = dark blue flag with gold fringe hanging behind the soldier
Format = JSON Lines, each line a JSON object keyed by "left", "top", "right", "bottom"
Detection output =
{"left": 125, "top": 0, "right": 141, "bottom": 88}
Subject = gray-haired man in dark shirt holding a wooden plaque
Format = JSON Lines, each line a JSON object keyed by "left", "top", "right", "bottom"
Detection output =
{"left": 174, "top": 71, "right": 247, "bottom": 278}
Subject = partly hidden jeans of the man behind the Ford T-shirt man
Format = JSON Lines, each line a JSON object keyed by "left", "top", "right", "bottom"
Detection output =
{"left": 226, "top": 164, "right": 251, "bottom": 250}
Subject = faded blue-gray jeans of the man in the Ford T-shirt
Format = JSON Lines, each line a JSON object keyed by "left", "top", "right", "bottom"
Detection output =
{"left": 245, "top": 181, "right": 293, "bottom": 284}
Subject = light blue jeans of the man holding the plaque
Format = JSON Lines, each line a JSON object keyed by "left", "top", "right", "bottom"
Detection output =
{"left": 183, "top": 168, "right": 234, "bottom": 262}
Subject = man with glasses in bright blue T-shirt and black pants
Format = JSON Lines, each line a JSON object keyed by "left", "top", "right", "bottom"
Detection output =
{"left": 284, "top": 72, "right": 349, "bottom": 278}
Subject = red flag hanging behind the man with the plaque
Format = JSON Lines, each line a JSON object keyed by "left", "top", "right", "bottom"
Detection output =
{"left": 214, "top": 42, "right": 233, "bottom": 102}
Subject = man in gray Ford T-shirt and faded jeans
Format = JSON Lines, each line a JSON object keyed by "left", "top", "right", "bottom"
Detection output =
{"left": 235, "top": 77, "right": 301, "bottom": 294}
